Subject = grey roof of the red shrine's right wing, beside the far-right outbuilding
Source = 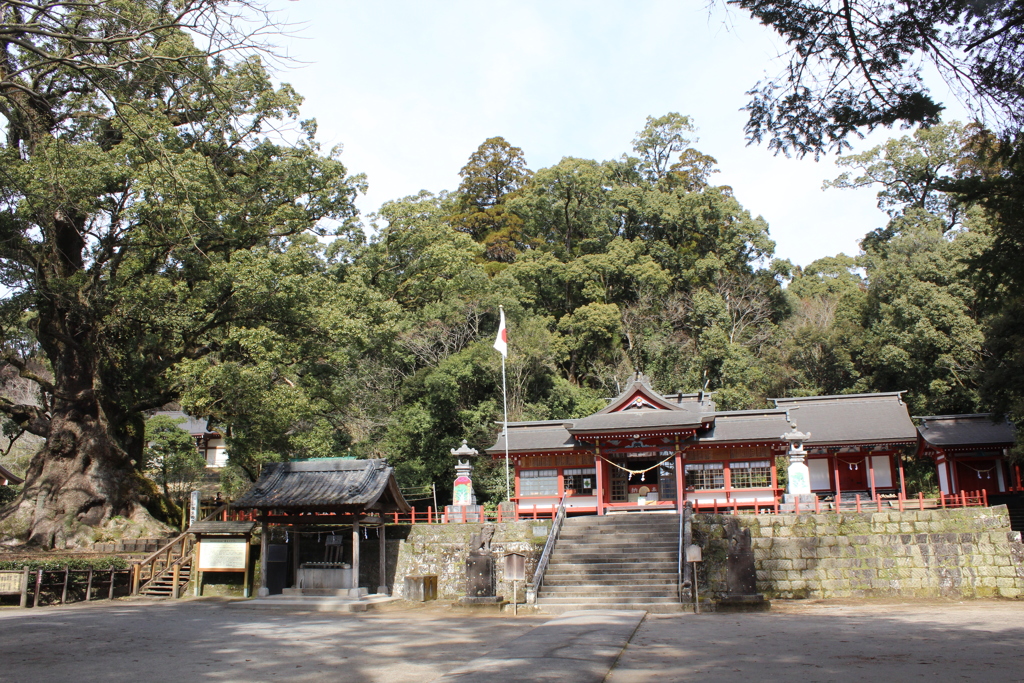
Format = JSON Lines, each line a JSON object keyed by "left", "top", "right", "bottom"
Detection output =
{"left": 771, "top": 391, "right": 918, "bottom": 445}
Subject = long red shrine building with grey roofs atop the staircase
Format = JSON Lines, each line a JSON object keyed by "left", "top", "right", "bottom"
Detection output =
{"left": 487, "top": 374, "right": 937, "bottom": 515}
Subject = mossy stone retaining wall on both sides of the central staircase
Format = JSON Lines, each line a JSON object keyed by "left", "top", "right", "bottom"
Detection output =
{"left": 387, "top": 506, "right": 1024, "bottom": 599}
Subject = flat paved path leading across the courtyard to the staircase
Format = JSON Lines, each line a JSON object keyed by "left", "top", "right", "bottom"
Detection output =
{"left": 436, "top": 609, "right": 646, "bottom": 683}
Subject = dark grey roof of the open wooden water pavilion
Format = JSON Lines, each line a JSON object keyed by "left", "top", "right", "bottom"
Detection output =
{"left": 233, "top": 458, "right": 410, "bottom": 512}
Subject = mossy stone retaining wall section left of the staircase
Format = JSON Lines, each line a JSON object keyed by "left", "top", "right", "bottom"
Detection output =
{"left": 392, "top": 520, "right": 551, "bottom": 601}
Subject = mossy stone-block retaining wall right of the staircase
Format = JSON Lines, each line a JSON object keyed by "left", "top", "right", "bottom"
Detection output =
{"left": 694, "top": 506, "right": 1024, "bottom": 598}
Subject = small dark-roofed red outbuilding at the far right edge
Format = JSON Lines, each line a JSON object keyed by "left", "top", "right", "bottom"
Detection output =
{"left": 918, "top": 414, "right": 1024, "bottom": 496}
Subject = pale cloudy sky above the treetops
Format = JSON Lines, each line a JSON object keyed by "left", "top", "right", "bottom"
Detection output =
{"left": 260, "top": 0, "right": 962, "bottom": 265}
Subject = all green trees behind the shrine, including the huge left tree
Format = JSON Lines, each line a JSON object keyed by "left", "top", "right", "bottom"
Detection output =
{"left": 0, "top": 0, "right": 1024, "bottom": 547}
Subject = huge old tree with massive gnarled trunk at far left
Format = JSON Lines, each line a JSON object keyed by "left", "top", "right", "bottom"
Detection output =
{"left": 0, "top": 0, "right": 359, "bottom": 547}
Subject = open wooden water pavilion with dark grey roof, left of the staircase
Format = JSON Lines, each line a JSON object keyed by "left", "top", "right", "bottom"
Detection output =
{"left": 233, "top": 458, "right": 410, "bottom": 596}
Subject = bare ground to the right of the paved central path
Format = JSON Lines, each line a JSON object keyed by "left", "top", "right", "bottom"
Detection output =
{"left": 606, "top": 601, "right": 1024, "bottom": 683}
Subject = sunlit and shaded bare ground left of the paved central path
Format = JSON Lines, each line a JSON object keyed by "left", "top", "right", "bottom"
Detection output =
{"left": 0, "top": 599, "right": 547, "bottom": 683}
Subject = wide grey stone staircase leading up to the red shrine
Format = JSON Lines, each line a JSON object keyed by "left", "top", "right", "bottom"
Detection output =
{"left": 537, "top": 512, "right": 682, "bottom": 614}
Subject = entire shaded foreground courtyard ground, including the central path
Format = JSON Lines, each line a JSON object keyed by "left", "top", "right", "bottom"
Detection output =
{"left": 0, "top": 600, "right": 1024, "bottom": 683}
